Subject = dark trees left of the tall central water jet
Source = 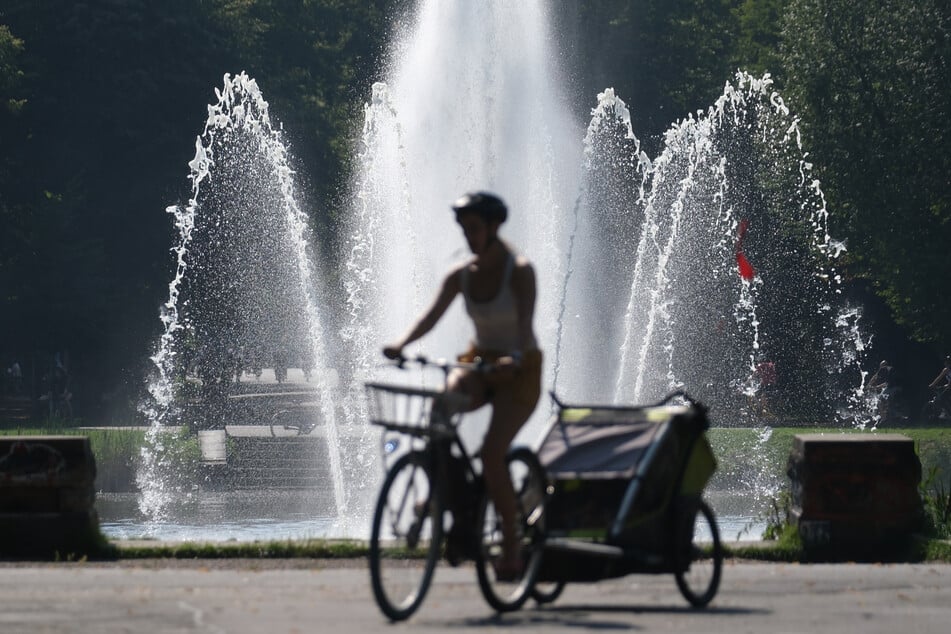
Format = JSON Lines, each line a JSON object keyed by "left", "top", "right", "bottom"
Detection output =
{"left": 0, "top": 0, "right": 398, "bottom": 414}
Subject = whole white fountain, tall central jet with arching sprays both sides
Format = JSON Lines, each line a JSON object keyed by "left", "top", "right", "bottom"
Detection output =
{"left": 121, "top": 1, "right": 874, "bottom": 537}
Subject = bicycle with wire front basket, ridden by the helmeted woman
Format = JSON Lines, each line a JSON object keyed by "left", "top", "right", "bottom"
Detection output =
{"left": 366, "top": 357, "right": 548, "bottom": 621}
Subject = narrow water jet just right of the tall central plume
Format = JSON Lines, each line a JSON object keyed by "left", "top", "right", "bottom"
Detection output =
{"left": 549, "top": 89, "right": 650, "bottom": 402}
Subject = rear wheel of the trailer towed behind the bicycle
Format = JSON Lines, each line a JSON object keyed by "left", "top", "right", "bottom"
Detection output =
{"left": 674, "top": 500, "right": 723, "bottom": 608}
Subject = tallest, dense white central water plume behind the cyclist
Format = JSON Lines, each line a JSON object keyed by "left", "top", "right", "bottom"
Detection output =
{"left": 343, "top": 1, "right": 580, "bottom": 452}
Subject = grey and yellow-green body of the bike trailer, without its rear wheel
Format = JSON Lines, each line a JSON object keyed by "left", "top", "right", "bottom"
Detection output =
{"left": 538, "top": 394, "right": 716, "bottom": 581}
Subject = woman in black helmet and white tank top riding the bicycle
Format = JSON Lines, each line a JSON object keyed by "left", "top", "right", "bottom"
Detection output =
{"left": 383, "top": 192, "right": 542, "bottom": 580}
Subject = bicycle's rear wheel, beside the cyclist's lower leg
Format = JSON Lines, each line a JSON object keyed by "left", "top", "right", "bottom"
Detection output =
{"left": 476, "top": 448, "right": 548, "bottom": 612}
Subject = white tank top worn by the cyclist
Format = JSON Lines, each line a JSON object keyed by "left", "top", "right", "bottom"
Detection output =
{"left": 460, "top": 253, "right": 534, "bottom": 352}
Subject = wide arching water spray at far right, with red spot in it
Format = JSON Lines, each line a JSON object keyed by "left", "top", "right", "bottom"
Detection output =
{"left": 600, "top": 72, "right": 861, "bottom": 424}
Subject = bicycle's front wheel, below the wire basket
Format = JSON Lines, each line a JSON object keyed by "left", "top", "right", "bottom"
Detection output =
{"left": 369, "top": 451, "right": 443, "bottom": 621}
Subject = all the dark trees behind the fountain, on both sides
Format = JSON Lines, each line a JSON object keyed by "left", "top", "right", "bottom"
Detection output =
{"left": 0, "top": 0, "right": 951, "bottom": 418}
